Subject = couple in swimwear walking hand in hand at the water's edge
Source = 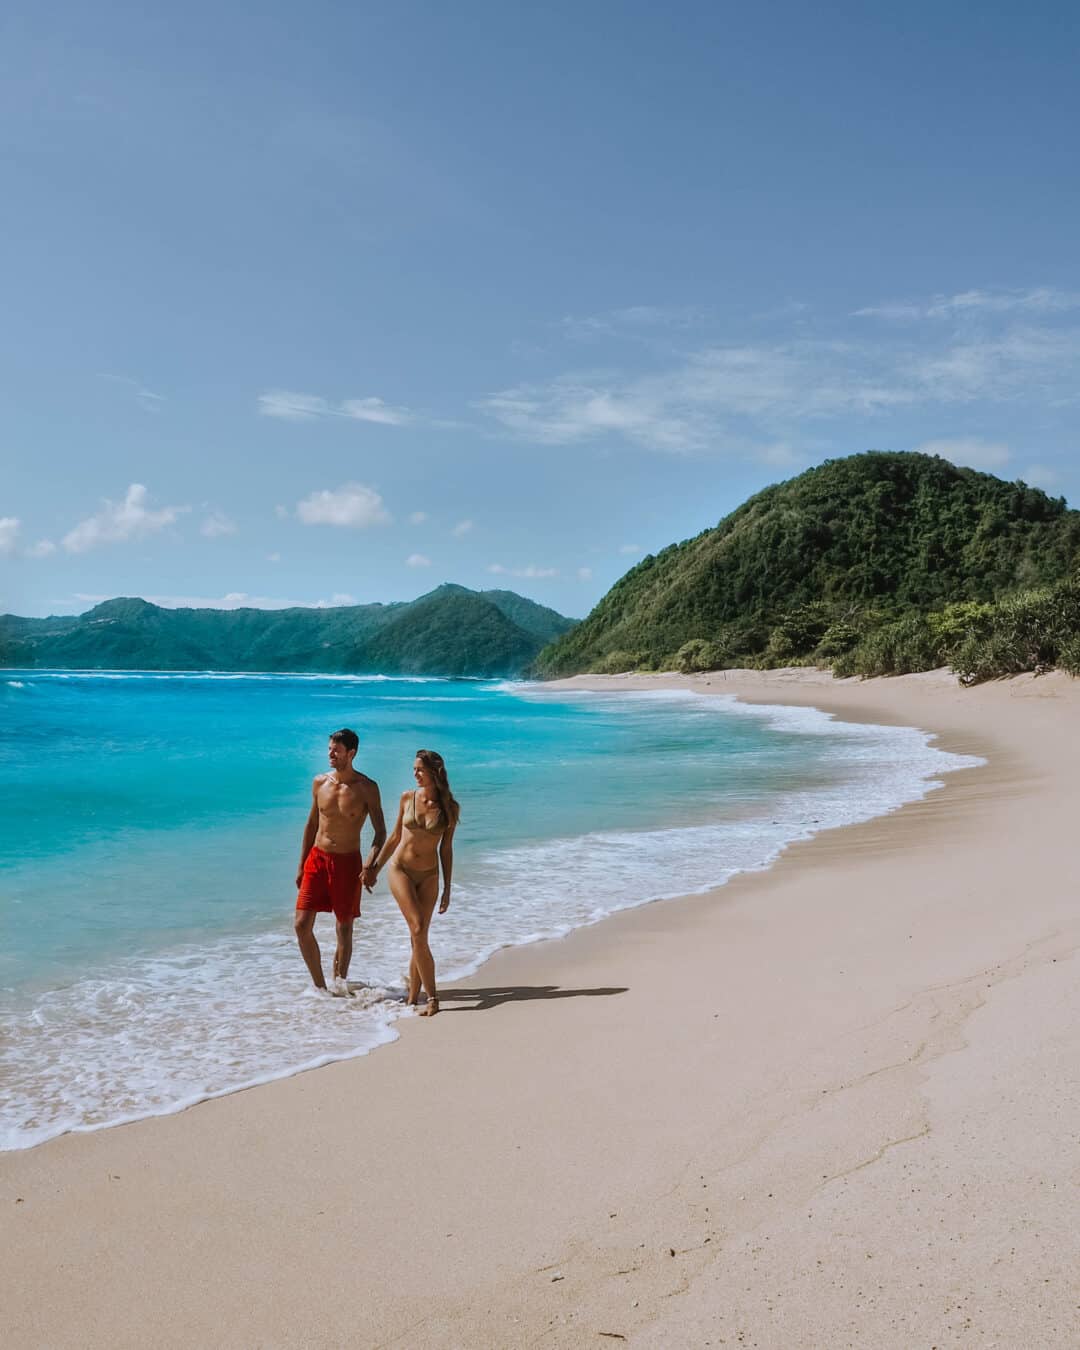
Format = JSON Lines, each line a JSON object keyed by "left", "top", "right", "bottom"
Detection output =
{"left": 294, "top": 726, "right": 460, "bottom": 1017}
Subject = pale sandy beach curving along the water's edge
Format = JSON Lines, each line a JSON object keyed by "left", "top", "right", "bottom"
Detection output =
{"left": 0, "top": 670, "right": 1080, "bottom": 1350}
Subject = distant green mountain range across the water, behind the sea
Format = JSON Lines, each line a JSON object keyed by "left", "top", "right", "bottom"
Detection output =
{"left": 0, "top": 585, "right": 574, "bottom": 678}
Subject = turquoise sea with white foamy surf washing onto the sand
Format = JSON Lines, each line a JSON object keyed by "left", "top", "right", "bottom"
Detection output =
{"left": 0, "top": 671, "right": 968, "bottom": 1148}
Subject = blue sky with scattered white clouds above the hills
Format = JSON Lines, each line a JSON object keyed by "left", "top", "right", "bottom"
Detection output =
{"left": 0, "top": 0, "right": 1080, "bottom": 617}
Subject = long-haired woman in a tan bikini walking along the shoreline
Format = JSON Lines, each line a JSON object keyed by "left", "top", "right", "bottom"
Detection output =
{"left": 375, "top": 751, "right": 460, "bottom": 1017}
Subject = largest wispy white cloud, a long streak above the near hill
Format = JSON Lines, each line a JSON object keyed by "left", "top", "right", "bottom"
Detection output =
{"left": 475, "top": 303, "right": 1080, "bottom": 450}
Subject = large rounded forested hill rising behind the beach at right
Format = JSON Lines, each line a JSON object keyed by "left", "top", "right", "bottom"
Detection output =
{"left": 535, "top": 451, "right": 1080, "bottom": 678}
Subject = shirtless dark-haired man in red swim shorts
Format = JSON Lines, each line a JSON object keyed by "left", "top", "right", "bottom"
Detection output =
{"left": 293, "top": 728, "right": 386, "bottom": 995}
